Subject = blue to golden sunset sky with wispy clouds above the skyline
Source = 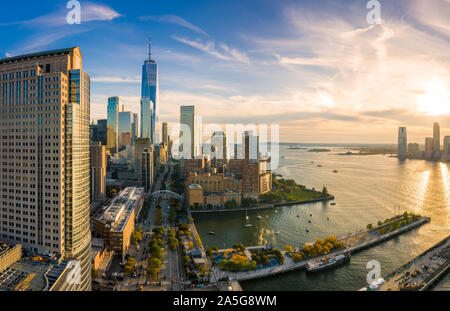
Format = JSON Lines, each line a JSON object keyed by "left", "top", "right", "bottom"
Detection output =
{"left": 0, "top": 0, "right": 450, "bottom": 143}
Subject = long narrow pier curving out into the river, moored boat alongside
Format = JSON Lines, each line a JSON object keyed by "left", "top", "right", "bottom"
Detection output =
{"left": 211, "top": 217, "right": 431, "bottom": 282}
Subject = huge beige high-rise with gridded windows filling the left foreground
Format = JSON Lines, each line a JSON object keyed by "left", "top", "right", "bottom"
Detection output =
{"left": 0, "top": 47, "right": 91, "bottom": 290}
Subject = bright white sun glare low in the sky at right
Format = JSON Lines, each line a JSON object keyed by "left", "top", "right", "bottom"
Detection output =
{"left": 418, "top": 78, "right": 450, "bottom": 116}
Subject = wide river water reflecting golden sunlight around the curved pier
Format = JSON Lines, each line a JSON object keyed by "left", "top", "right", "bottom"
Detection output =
{"left": 194, "top": 145, "right": 450, "bottom": 291}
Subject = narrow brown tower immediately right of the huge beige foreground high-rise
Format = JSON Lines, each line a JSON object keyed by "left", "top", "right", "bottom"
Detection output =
{"left": 91, "top": 142, "right": 106, "bottom": 201}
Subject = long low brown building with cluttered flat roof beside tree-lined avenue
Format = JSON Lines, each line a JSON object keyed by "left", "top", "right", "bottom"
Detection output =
{"left": 93, "top": 187, "right": 144, "bottom": 260}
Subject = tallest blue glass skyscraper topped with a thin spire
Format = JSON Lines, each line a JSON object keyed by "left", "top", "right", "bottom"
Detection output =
{"left": 141, "top": 37, "right": 160, "bottom": 144}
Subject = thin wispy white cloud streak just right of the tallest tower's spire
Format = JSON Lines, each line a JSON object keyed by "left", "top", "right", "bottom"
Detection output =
{"left": 172, "top": 36, "right": 250, "bottom": 64}
